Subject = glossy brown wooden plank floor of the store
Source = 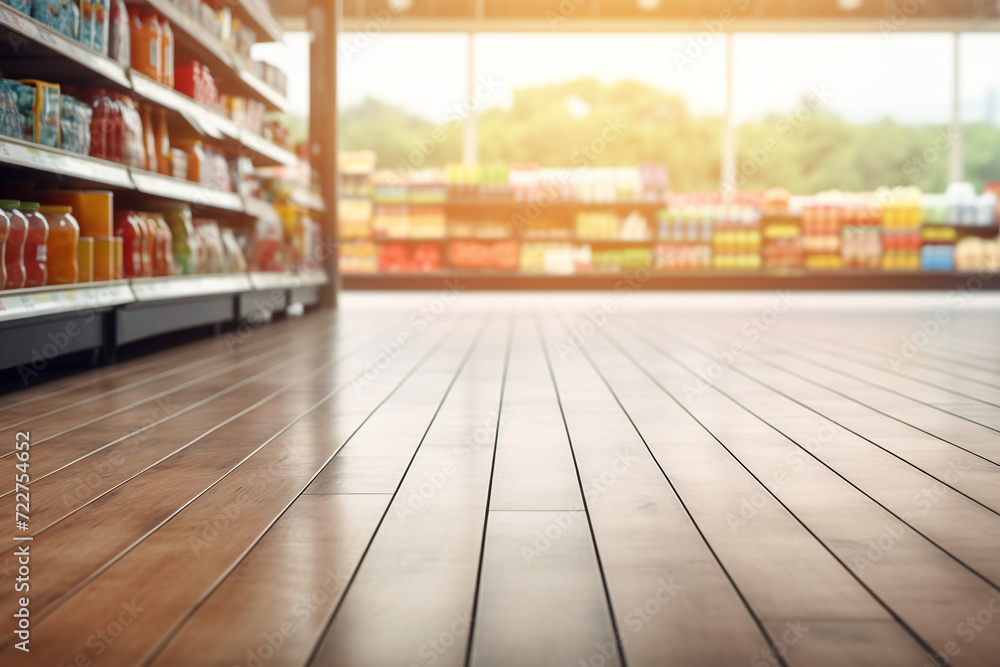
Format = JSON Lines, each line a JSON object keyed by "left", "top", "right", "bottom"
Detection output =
{"left": 0, "top": 290, "right": 1000, "bottom": 667}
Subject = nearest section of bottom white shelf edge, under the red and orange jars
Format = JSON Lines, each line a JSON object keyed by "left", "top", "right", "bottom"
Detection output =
{"left": 0, "top": 281, "right": 135, "bottom": 322}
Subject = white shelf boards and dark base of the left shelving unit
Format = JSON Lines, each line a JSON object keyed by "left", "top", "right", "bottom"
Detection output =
{"left": 0, "top": 0, "right": 331, "bottom": 374}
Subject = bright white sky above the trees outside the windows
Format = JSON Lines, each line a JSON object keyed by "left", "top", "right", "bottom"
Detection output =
{"left": 255, "top": 33, "right": 1000, "bottom": 124}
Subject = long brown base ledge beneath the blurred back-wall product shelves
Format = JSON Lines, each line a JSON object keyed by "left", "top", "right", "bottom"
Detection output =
{"left": 341, "top": 271, "right": 1000, "bottom": 291}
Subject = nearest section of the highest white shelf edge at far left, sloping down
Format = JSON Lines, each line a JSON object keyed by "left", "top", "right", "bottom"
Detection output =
{"left": 0, "top": 5, "right": 131, "bottom": 89}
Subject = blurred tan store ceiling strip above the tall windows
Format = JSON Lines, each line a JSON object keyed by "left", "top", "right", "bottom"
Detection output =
{"left": 277, "top": 0, "right": 1000, "bottom": 32}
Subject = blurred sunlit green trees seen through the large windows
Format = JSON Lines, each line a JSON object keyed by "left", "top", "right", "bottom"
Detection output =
{"left": 340, "top": 78, "right": 1000, "bottom": 194}
